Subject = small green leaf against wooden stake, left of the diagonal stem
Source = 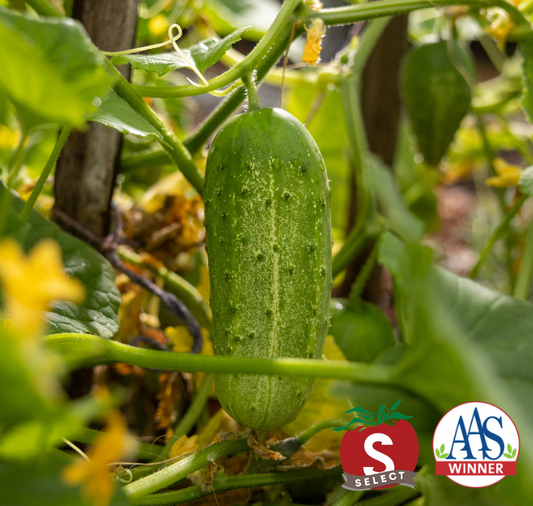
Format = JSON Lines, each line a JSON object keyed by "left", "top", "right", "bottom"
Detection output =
{"left": 88, "top": 91, "right": 163, "bottom": 142}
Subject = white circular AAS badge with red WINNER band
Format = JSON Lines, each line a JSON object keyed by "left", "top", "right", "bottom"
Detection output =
{"left": 433, "top": 402, "right": 520, "bottom": 488}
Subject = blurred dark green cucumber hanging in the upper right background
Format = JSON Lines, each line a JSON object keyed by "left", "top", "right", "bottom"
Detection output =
{"left": 402, "top": 40, "right": 473, "bottom": 165}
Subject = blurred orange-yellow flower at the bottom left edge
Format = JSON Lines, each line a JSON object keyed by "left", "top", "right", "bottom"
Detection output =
{"left": 62, "top": 411, "right": 132, "bottom": 506}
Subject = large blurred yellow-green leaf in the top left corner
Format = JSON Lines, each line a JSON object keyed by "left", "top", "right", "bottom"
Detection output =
{"left": 0, "top": 7, "right": 114, "bottom": 128}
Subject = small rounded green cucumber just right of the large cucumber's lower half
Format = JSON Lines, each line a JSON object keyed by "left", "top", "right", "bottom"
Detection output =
{"left": 329, "top": 299, "right": 396, "bottom": 362}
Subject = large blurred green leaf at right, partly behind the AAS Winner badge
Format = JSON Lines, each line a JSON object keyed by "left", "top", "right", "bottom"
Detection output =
{"left": 380, "top": 234, "right": 533, "bottom": 504}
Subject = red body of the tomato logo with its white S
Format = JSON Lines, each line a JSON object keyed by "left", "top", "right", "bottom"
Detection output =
{"left": 341, "top": 420, "right": 418, "bottom": 489}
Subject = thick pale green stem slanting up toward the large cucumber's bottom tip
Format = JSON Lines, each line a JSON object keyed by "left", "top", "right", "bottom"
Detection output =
{"left": 123, "top": 439, "right": 250, "bottom": 499}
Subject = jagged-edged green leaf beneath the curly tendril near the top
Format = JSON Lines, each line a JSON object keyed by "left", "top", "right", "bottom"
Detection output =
{"left": 111, "top": 27, "right": 248, "bottom": 76}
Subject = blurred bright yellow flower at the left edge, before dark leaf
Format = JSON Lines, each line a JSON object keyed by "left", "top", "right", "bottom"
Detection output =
{"left": 0, "top": 239, "right": 85, "bottom": 336}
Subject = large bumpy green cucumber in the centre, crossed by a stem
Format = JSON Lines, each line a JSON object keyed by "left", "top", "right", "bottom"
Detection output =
{"left": 205, "top": 109, "right": 332, "bottom": 430}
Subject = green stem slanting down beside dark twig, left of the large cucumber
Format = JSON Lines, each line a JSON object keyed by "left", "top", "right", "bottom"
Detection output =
{"left": 117, "top": 246, "right": 213, "bottom": 333}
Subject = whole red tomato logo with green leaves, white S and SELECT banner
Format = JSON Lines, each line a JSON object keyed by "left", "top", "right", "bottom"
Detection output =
{"left": 333, "top": 399, "right": 418, "bottom": 490}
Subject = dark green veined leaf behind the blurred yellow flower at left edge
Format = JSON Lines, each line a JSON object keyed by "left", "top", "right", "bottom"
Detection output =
{"left": 0, "top": 184, "right": 120, "bottom": 338}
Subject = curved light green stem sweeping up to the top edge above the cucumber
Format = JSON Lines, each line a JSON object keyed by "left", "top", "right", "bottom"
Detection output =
{"left": 130, "top": 0, "right": 301, "bottom": 98}
